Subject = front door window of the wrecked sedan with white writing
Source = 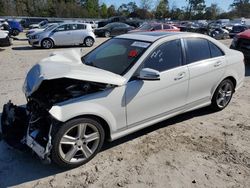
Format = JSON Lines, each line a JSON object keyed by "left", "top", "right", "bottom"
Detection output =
{"left": 144, "top": 40, "right": 182, "bottom": 72}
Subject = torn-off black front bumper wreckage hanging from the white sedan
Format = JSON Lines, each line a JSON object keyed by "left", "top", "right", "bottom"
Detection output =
{"left": 1, "top": 102, "right": 52, "bottom": 162}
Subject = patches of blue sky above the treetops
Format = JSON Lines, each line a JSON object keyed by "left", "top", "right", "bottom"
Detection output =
{"left": 100, "top": 0, "right": 233, "bottom": 11}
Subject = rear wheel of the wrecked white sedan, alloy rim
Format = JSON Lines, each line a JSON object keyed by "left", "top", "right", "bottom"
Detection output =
{"left": 211, "top": 79, "right": 234, "bottom": 111}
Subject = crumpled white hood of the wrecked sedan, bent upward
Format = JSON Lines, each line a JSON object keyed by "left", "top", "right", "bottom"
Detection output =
{"left": 23, "top": 49, "right": 126, "bottom": 96}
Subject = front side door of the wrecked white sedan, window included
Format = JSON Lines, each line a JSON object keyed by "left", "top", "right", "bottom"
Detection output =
{"left": 126, "top": 40, "right": 189, "bottom": 126}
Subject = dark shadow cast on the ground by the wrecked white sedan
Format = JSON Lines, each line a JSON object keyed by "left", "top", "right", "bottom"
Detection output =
{"left": 0, "top": 108, "right": 215, "bottom": 187}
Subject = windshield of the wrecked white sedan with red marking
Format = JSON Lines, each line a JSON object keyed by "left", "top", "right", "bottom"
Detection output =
{"left": 82, "top": 38, "right": 151, "bottom": 75}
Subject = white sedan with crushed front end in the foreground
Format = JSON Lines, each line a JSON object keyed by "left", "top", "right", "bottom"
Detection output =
{"left": 1, "top": 32, "right": 245, "bottom": 168}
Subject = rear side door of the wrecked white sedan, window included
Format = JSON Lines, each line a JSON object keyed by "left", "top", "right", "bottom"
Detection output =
{"left": 185, "top": 38, "right": 226, "bottom": 105}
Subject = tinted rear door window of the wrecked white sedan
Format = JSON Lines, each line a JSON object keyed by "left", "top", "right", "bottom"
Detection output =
{"left": 186, "top": 38, "right": 210, "bottom": 63}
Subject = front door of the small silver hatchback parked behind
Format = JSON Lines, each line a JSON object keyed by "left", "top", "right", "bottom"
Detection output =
{"left": 51, "top": 24, "right": 74, "bottom": 46}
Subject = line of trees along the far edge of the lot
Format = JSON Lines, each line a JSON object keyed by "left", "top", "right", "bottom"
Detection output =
{"left": 0, "top": 0, "right": 250, "bottom": 20}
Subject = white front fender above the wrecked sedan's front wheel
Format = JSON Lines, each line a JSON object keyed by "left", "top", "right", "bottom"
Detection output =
{"left": 49, "top": 86, "right": 127, "bottom": 134}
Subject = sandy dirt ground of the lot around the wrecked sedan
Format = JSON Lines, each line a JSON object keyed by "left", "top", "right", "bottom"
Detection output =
{"left": 0, "top": 36, "right": 250, "bottom": 188}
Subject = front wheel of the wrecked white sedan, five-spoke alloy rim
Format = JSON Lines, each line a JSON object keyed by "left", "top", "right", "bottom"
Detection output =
{"left": 51, "top": 118, "right": 105, "bottom": 168}
